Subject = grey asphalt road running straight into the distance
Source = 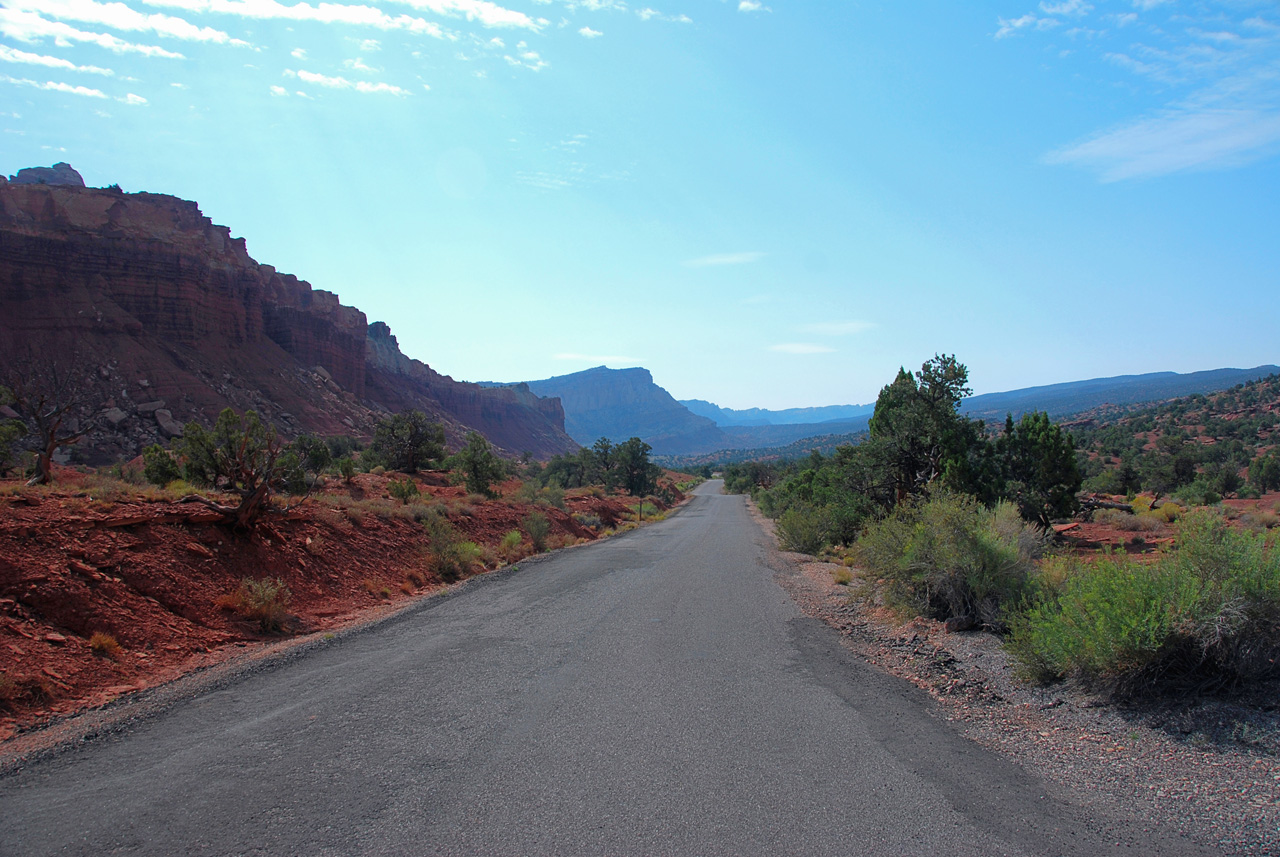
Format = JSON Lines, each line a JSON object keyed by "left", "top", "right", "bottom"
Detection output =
{"left": 0, "top": 482, "right": 1201, "bottom": 857}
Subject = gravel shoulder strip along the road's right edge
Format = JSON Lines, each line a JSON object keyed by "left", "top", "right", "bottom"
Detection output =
{"left": 749, "top": 503, "right": 1280, "bottom": 856}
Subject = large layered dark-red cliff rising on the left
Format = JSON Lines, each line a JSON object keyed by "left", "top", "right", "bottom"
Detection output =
{"left": 0, "top": 173, "right": 576, "bottom": 462}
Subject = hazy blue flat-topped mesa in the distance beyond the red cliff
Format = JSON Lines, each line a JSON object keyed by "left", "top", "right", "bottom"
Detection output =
{"left": 517, "top": 366, "right": 732, "bottom": 455}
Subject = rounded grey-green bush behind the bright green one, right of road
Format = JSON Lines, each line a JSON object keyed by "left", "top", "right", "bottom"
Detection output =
{"left": 856, "top": 492, "right": 1047, "bottom": 631}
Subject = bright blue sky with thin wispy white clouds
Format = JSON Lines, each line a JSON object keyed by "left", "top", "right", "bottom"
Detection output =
{"left": 0, "top": 0, "right": 1280, "bottom": 408}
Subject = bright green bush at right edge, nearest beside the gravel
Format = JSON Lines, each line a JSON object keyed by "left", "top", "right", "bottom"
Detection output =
{"left": 1009, "top": 510, "right": 1280, "bottom": 696}
